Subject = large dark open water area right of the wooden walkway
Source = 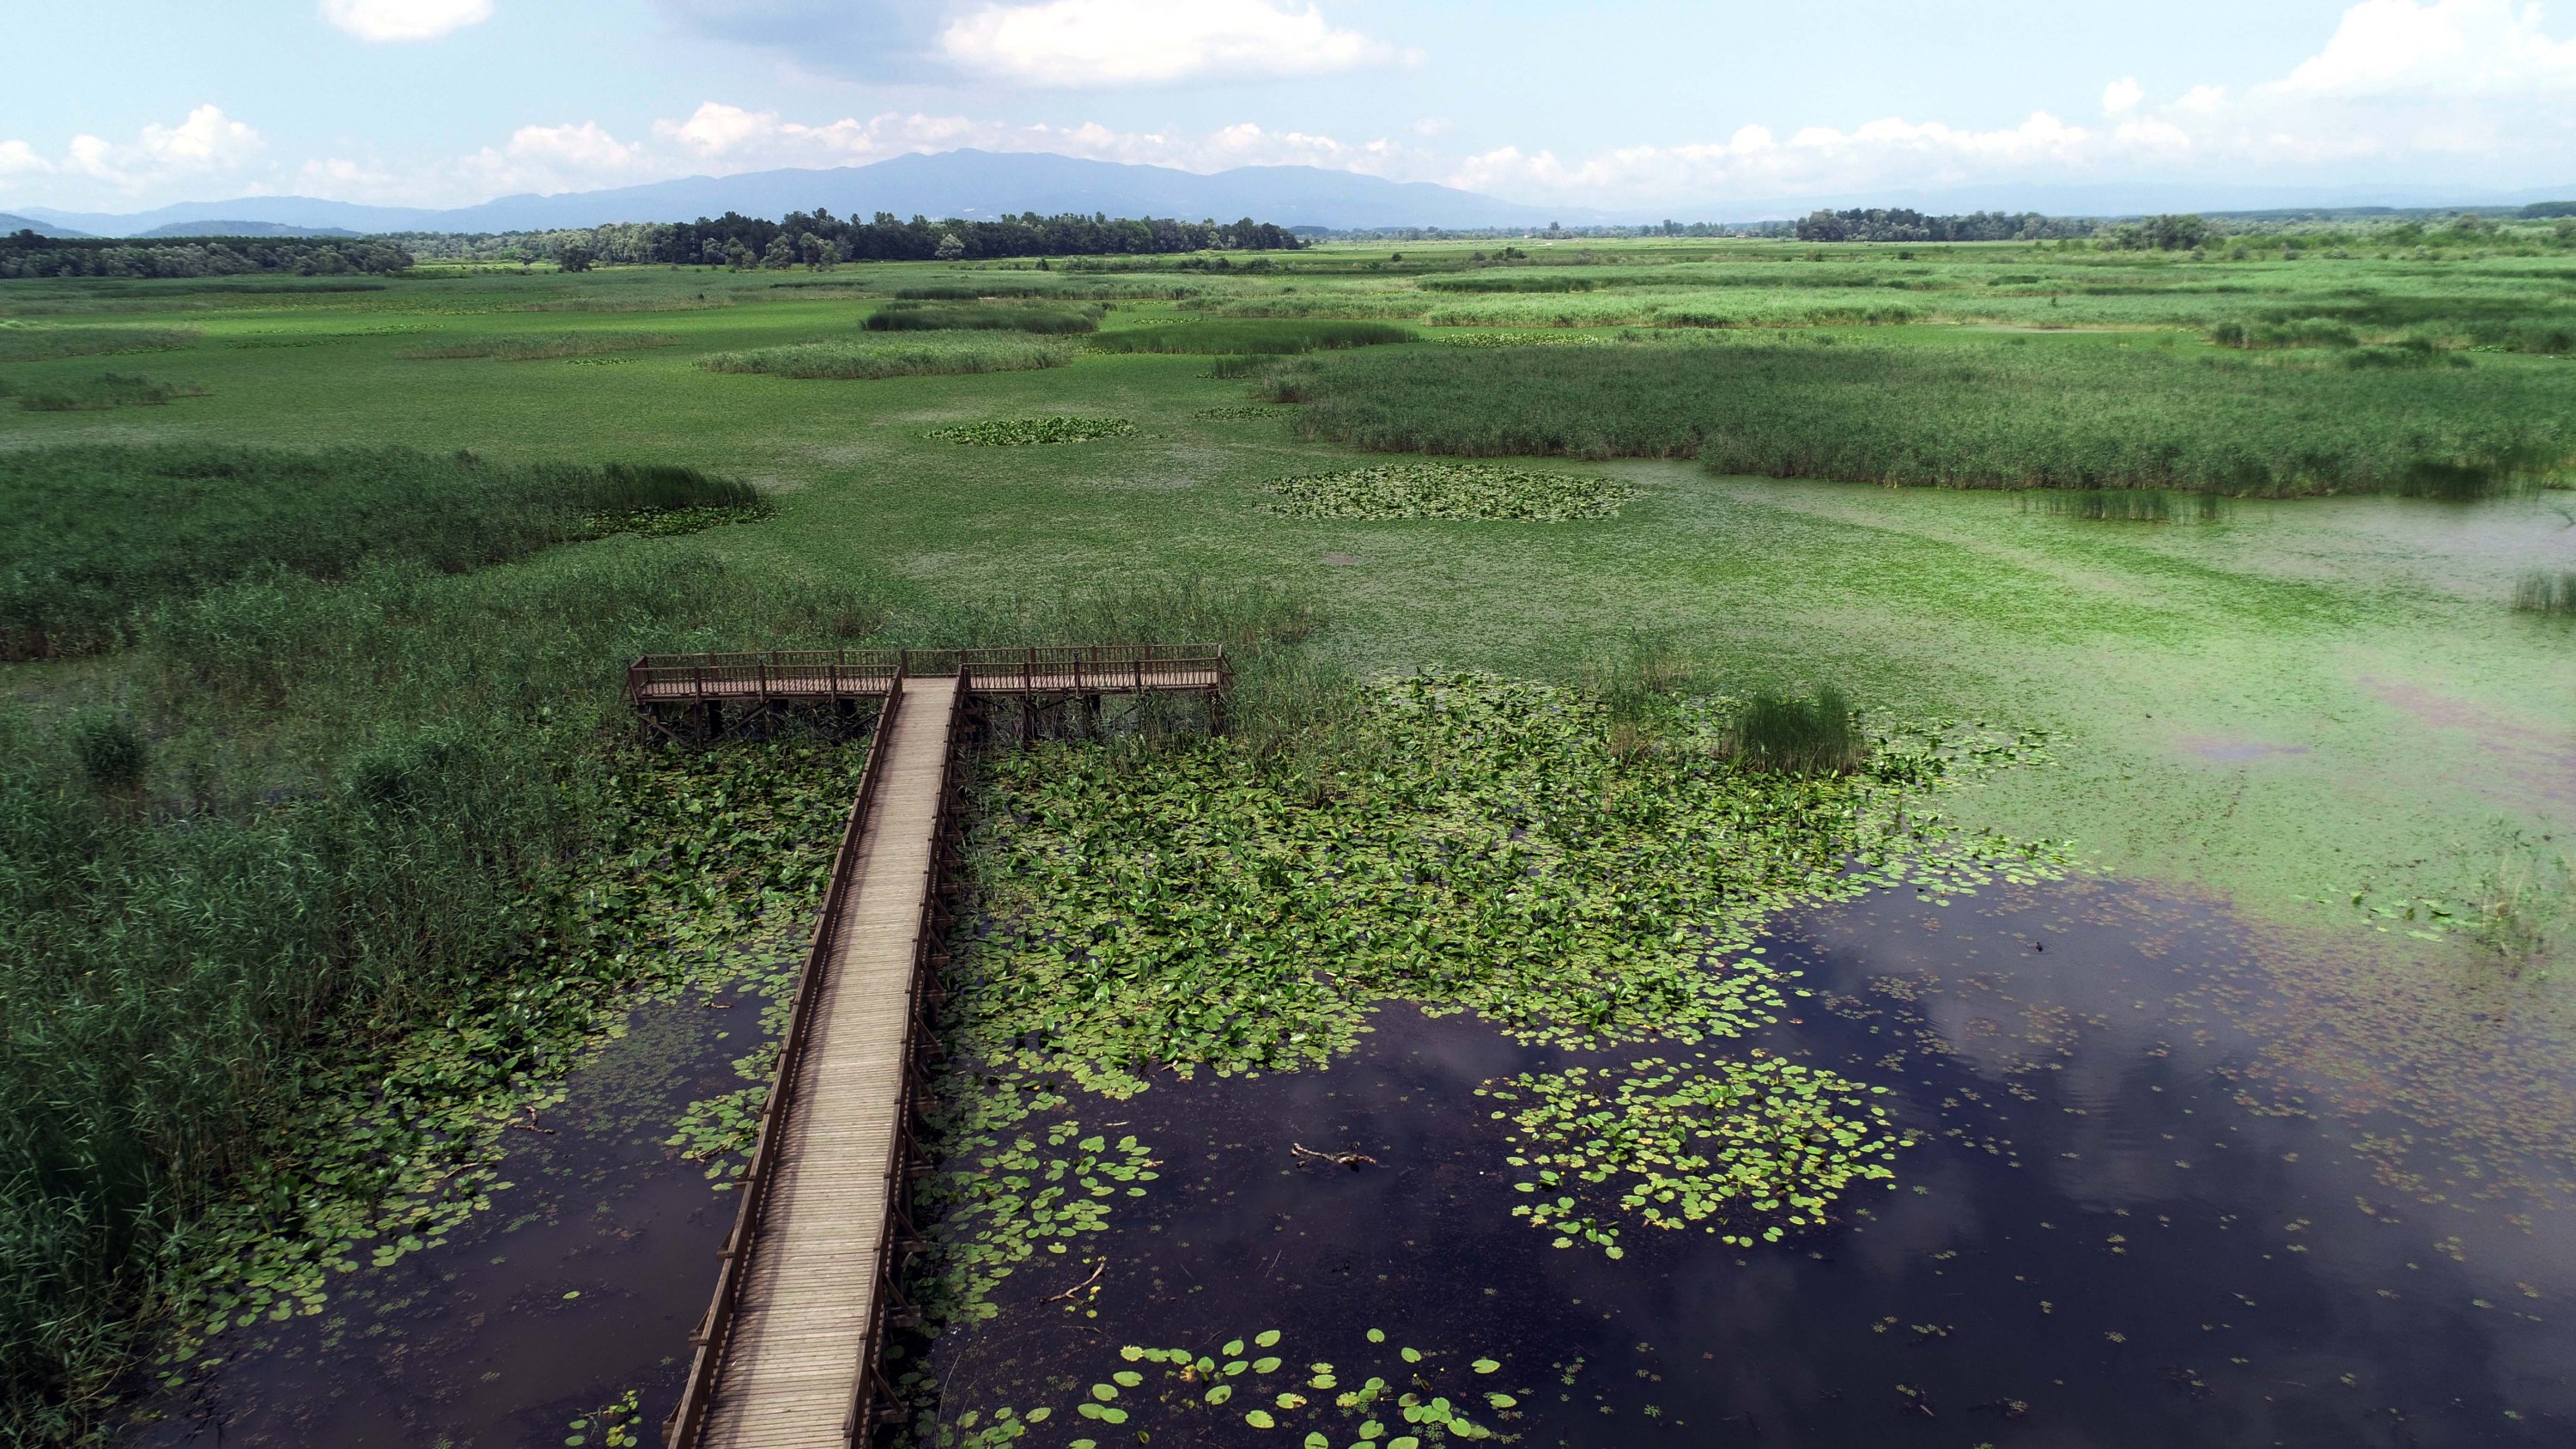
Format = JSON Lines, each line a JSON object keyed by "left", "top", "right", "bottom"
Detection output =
{"left": 940, "top": 885, "right": 2576, "bottom": 1449}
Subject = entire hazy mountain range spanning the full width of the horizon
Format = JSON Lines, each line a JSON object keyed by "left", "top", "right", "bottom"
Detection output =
{"left": 0, "top": 149, "right": 2576, "bottom": 237}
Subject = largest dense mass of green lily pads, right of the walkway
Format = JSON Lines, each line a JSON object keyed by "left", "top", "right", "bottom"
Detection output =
{"left": 953, "top": 675, "right": 2058, "bottom": 1096}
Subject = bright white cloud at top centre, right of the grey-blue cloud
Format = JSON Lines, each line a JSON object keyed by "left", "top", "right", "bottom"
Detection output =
{"left": 938, "top": 0, "right": 1394, "bottom": 85}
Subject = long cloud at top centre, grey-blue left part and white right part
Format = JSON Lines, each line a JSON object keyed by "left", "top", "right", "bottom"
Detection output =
{"left": 662, "top": 0, "right": 1399, "bottom": 88}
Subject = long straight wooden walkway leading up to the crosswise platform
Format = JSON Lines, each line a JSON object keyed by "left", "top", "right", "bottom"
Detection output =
{"left": 670, "top": 678, "right": 961, "bottom": 1449}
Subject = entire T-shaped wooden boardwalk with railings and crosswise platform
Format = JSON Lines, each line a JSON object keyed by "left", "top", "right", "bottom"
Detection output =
{"left": 659, "top": 644, "right": 1229, "bottom": 1449}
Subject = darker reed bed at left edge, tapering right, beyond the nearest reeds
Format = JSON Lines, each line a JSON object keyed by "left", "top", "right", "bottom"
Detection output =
{"left": 0, "top": 446, "right": 757, "bottom": 660}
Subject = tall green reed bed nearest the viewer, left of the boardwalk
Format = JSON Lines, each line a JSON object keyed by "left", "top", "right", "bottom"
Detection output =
{"left": 0, "top": 544, "right": 881, "bottom": 1441}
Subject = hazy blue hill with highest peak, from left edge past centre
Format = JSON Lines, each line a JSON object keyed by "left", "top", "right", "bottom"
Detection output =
{"left": 4, "top": 149, "right": 1613, "bottom": 237}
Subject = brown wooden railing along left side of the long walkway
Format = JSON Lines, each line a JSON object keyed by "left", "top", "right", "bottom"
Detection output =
{"left": 670, "top": 678, "right": 907, "bottom": 1444}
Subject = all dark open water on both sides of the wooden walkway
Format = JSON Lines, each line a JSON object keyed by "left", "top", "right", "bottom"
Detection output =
{"left": 137, "top": 882, "right": 2576, "bottom": 1449}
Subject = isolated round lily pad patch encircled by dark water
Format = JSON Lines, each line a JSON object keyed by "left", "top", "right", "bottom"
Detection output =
{"left": 1476, "top": 1052, "right": 1906, "bottom": 1258}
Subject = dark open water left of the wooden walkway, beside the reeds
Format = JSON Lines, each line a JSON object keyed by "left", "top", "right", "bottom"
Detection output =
{"left": 131, "top": 995, "right": 760, "bottom": 1449}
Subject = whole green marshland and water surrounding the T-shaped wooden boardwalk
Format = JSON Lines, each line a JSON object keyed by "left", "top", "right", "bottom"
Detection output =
{"left": 0, "top": 242, "right": 2576, "bottom": 1449}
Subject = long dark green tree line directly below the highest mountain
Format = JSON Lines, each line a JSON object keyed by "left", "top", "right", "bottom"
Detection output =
{"left": 392, "top": 209, "right": 1306, "bottom": 271}
